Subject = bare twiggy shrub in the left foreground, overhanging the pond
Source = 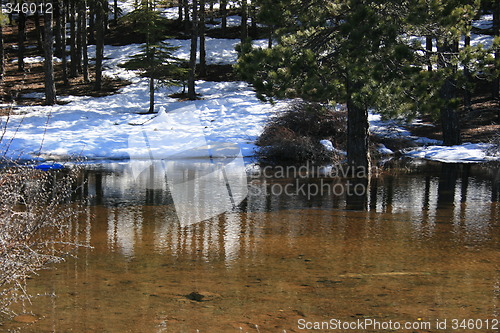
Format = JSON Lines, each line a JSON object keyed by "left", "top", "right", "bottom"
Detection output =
{"left": 0, "top": 164, "right": 78, "bottom": 314}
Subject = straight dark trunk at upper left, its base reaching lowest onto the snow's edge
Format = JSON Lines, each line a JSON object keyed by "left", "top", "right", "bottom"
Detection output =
{"left": 44, "top": 6, "right": 57, "bottom": 105}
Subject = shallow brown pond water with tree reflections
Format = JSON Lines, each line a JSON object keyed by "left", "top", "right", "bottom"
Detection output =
{"left": 0, "top": 161, "right": 500, "bottom": 332}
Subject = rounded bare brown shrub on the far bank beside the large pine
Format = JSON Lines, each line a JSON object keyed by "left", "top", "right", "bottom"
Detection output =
{"left": 256, "top": 102, "right": 347, "bottom": 162}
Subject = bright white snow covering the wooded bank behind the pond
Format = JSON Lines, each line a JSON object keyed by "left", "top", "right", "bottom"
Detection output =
{"left": 0, "top": 3, "right": 500, "bottom": 162}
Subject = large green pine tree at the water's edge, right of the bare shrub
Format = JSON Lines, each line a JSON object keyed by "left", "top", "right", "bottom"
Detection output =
{"left": 237, "top": 0, "right": 418, "bottom": 170}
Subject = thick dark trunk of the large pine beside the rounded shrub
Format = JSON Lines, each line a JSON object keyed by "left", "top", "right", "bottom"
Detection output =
{"left": 347, "top": 82, "right": 370, "bottom": 169}
